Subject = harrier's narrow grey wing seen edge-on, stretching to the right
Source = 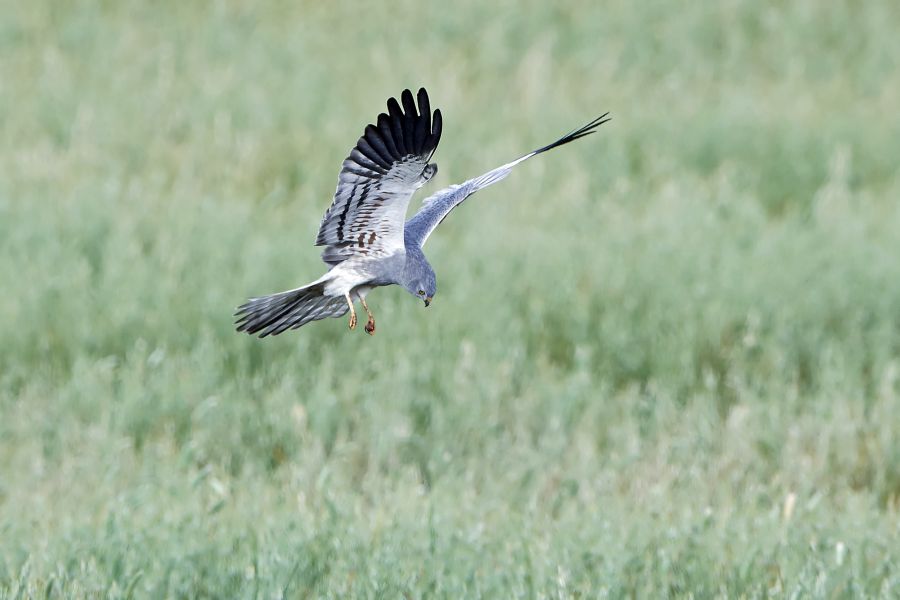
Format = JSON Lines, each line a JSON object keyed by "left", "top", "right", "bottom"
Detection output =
{"left": 406, "top": 113, "right": 610, "bottom": 247}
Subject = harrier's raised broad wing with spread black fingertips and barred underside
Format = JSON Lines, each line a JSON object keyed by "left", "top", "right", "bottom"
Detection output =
{"left": 316, "top": 89, "right": 441, "bottom": 266}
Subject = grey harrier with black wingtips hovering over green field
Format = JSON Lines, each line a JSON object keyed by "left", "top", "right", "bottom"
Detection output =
{"left": 235, "top": 89, "right": 609, "bottom": 337}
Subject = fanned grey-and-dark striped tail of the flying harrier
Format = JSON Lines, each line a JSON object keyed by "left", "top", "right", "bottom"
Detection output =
{"left": 234, "top": 281, "right": 349, "bottom": 338}
